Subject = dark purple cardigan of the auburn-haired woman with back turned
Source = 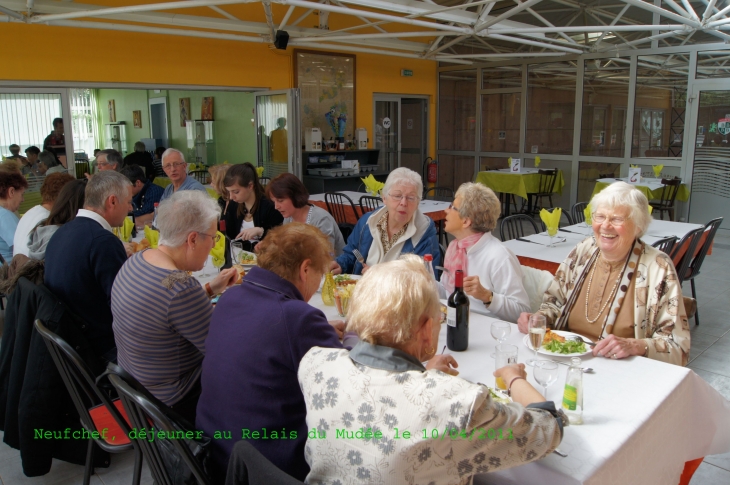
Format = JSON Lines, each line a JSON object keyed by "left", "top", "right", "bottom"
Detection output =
{"left": 196, "top": 267, "right": 343, "bottom": 480}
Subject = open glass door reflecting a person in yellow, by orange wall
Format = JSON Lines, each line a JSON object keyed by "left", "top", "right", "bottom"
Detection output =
{"left": 254, "top": 89, "right": 302, "bottom": 179}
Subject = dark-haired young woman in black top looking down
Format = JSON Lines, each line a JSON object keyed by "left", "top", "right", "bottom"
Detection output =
{"left": 223, "top": 162, "right": 284, "bottom": 251}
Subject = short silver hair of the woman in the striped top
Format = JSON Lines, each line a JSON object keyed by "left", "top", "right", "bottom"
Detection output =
{"left": 157, "top": 190, "right": 221, "bottom": 248}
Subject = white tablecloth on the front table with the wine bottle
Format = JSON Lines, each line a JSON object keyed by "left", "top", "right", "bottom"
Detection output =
{"left": 310, "top": 296, "right": 730, "bottom": 485}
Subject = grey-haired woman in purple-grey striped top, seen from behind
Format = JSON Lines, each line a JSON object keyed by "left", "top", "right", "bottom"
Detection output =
{"left": 111, "top": 190, "right": 238, "bottom": 422}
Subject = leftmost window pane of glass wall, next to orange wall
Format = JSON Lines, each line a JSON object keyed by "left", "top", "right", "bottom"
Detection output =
{"left": 439, "top": 71, "right": 477, "bottom": 151}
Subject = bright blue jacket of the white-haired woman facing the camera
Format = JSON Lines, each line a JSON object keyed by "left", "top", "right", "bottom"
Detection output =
{"left": 337, "top": 207, "right": 441, "bottom": 275}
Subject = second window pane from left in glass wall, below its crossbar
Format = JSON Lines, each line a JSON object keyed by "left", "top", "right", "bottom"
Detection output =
{"left": 482, "top": 93, "right": 521, "bottom": 153}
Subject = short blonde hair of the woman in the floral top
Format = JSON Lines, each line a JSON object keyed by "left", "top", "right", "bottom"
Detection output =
{"left": 347, "top": 254, "right": 440, "bottom": 348}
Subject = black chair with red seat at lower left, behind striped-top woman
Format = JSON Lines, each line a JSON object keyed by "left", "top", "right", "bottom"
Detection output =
{"left": 35, "top": 320, "right": 142, "bottom": 485}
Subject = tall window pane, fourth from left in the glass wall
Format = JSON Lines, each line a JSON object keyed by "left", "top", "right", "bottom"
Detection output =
{"left": 580, "top": 57, "right": 629, "bottom": 157}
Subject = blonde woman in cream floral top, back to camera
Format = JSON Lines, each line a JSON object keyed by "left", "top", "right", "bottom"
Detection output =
{"left": 298, "top": 255, "right": 563, "bottom": 485}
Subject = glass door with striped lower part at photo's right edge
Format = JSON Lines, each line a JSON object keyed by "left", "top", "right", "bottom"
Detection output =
{"left": 689, "top": 84, "right": 730, "bottom": 231}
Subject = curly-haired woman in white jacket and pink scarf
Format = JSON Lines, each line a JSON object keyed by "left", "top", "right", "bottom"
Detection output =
{"left": 439, "top": 183, "right": 530, "bottom": 323}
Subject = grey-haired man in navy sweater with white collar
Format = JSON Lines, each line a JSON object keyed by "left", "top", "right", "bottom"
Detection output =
{"left": 44, "top": 170, "right": 132, "bottom": 361}
